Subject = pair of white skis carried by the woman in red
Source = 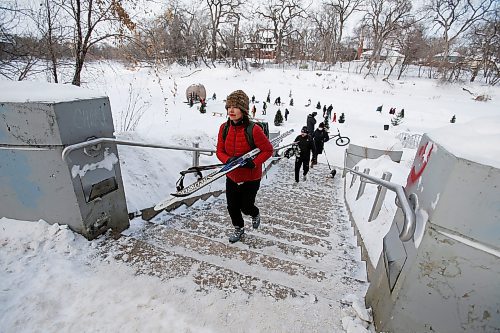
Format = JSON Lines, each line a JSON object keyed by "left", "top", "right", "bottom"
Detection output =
{"left": 154, "top": 129, "right": 293, "bottom": 211}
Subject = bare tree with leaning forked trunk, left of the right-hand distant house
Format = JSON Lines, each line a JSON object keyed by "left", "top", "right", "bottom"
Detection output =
{"left": 364, "top": 0, "right": 412, "bottom": 70}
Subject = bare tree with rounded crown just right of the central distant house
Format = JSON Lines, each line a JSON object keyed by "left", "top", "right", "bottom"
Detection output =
{"left": 257, "top": 0, "right": 306, "bottom": 63}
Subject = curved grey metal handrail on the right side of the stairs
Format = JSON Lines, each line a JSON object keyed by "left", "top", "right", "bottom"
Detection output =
{"left": 345, "top": 168, "right": 416, "bottom": 242}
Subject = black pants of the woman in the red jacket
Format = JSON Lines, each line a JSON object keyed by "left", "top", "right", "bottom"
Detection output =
{"left": 226, "top": 178, "right": 260, "bottom": 228}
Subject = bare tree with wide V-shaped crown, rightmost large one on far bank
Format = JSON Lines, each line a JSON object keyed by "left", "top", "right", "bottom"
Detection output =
{"left": 424, "top": 0, "right": 498, "bottom": 65}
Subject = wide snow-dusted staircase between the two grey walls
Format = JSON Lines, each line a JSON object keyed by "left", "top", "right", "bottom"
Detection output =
{"left": 99, "top": 160, "right": 367, "bottom": 332}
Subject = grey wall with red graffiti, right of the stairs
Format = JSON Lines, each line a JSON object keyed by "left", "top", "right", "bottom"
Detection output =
{"left": 367, "top": 135, "right": 500, "bottom": 332}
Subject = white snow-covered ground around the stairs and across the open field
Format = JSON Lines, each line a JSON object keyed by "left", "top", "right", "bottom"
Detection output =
{"left": 0, "top": 63, "right": 500, "bottom": 332}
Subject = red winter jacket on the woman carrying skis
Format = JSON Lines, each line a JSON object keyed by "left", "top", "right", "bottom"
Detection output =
{"left": 217, "top": 122, "right": 273, "bottom": 183}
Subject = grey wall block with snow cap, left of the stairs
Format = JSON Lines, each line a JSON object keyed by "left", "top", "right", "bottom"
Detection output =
{"left": 0, "top": 82, "right": 128, "bottom": 238}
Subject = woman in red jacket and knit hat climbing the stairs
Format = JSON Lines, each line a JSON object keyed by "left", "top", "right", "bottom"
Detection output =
{"left": 216, "top": 90, "right": 273, "bottom": 243}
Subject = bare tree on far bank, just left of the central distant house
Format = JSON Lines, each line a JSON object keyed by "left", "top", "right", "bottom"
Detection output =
{"left": 205, "top": 0, "right": 243, "bottom": 61}
